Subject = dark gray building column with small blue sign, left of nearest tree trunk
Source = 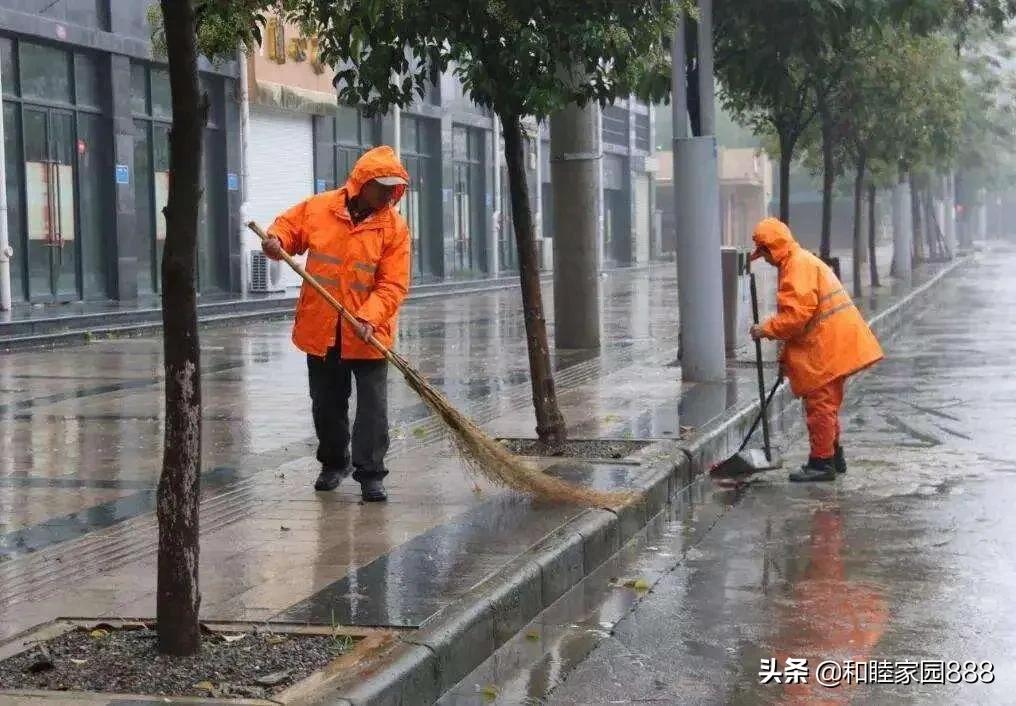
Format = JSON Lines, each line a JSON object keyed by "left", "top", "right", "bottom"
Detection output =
{"left": 110, "top": 54, "right": 140, "bottom": 301}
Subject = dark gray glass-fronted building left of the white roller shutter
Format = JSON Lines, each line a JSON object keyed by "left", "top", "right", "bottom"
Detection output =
{"left": 0, "top": 0, "right": 241, "bottom": 304}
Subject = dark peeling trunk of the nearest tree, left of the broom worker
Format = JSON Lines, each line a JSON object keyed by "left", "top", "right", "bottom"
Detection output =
{"left": 155, "top": 0, "right": 206, "bottom": 656}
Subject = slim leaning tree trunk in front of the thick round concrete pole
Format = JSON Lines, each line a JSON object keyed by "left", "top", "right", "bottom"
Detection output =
{"left": 500, "top": 115, "right": 567, "bottom": 446}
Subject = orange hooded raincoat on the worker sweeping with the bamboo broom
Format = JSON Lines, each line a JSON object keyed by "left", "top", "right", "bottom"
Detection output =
{"left": 268, "top": 146, "right": 410, "bottom": 360}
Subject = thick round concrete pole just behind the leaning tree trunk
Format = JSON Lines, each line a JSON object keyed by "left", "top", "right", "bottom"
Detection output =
{"left": 551, "top": 104, "right": 602, "bottom": 348}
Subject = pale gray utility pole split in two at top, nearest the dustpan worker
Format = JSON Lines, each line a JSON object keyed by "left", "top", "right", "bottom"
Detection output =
{"left": 671, "top": 0, "right": 726, "bottom": 382}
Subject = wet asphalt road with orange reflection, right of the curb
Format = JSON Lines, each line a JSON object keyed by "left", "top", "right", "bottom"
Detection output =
{"left": 467, "top": 253, "right": 1016, "bottom": 705}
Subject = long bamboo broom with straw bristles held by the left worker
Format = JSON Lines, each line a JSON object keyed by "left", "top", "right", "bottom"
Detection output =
{"left": 247, "top": 221, "right": 634, "bottom": 507}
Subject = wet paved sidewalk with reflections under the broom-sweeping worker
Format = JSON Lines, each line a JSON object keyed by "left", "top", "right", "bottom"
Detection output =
{"left": 0, "top": 245, "right": 902, "bottom": 650}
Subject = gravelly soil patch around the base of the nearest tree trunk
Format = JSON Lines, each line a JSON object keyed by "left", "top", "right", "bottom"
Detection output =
{"left": 0, "top": 627, "right": 355, "bottom": 699}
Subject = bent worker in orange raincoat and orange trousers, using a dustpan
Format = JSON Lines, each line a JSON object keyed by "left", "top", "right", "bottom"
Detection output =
{"left": 751, "top": 218, "right": 883, "bottom": 482}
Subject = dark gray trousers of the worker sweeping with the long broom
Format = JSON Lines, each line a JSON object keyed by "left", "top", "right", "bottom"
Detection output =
{"left": 307, "top": 345, "right": 390, "bottom": 482}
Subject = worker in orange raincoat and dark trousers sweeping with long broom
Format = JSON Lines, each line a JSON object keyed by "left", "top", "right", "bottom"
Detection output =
{"left": 263, "top": 146, "right": 410, "bottom": 502}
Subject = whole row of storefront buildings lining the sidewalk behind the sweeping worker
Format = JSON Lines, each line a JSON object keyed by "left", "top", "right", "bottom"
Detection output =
{"left": 0, "top": 0, "right": 658, "bottom": 305}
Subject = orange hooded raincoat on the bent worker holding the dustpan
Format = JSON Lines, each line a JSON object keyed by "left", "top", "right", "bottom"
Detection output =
{"left": 755, "top": 218, "right": 883, "bottom": 397}
